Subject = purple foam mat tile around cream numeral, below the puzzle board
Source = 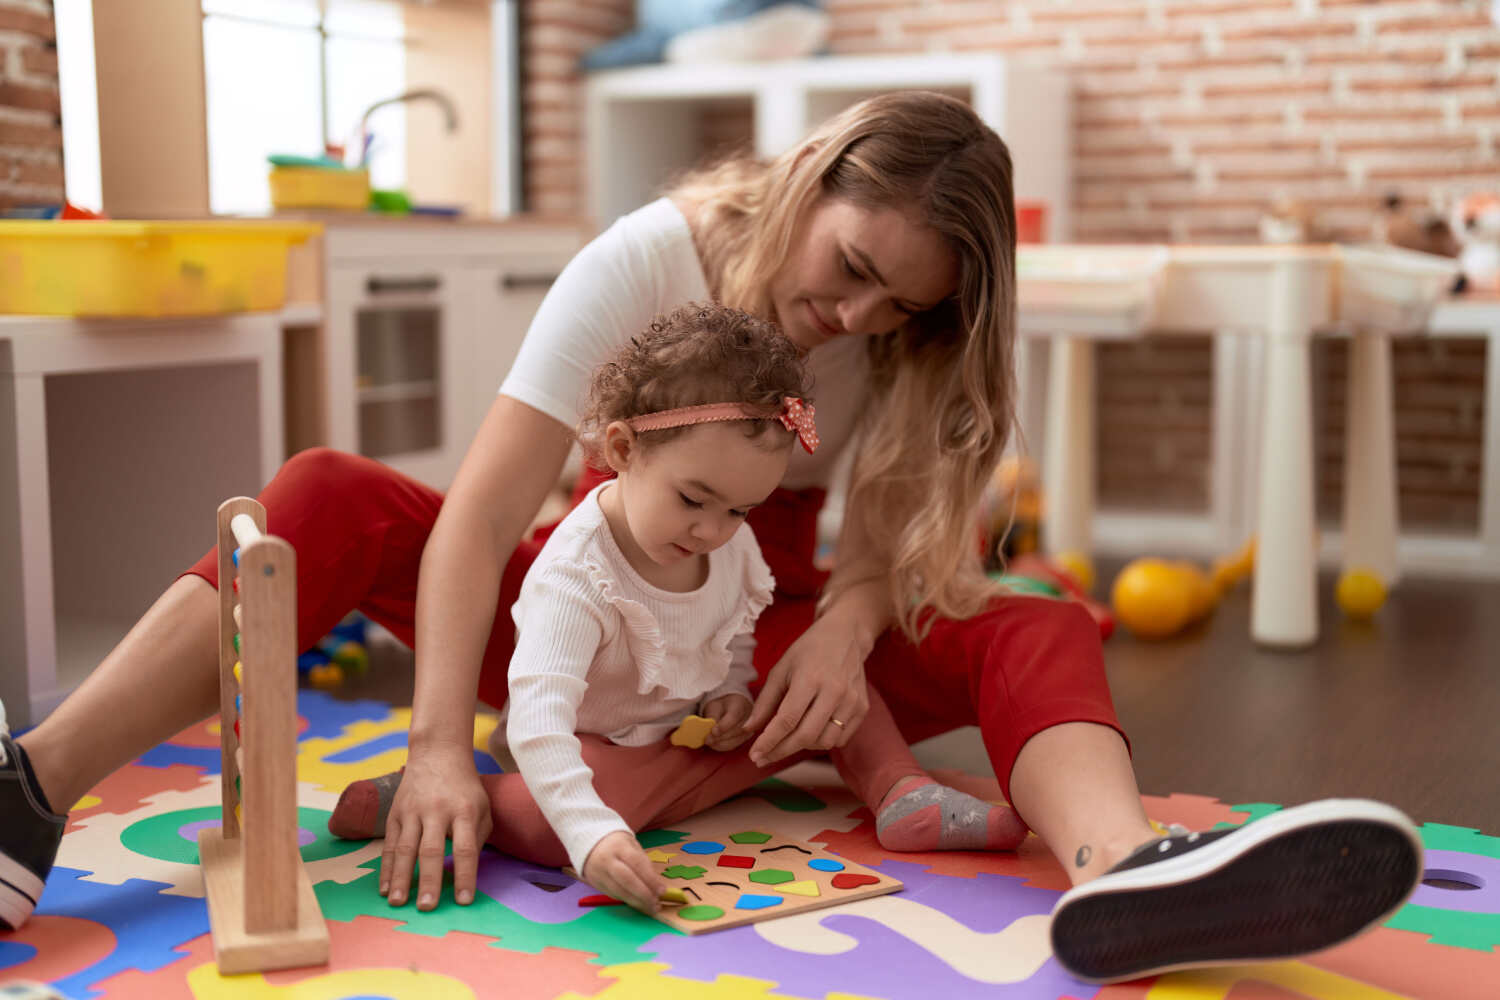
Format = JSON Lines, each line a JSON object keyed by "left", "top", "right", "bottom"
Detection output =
{"left": 641, "top": 861, "right": 1100, "bottom": 1000}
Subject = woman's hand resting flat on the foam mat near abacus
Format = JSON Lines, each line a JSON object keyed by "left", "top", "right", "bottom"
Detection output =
{"left": 380, "top": 745, "right": 491, "bottom": 910}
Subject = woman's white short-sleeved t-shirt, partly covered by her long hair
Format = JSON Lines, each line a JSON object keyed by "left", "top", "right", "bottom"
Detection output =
{"left": 500, "top": 198, "right": 870, "bottom": 489}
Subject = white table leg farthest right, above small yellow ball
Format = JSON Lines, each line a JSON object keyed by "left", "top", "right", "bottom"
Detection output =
{"left": 1343, "top": 331, "right": 1400, "bottom": 586}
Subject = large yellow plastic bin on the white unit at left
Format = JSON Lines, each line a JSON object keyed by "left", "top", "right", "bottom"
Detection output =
{"left": 0, "top": 220, "right": 323, "bottom": 316}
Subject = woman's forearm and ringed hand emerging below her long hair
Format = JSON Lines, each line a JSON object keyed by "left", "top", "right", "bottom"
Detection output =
{"left": 746, "top": 497, "right": 896, "bottom": 766}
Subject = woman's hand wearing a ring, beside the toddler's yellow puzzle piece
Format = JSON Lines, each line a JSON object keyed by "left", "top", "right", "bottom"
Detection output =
{"left": 746, "top": 613, "right": 870, "bottom": 768}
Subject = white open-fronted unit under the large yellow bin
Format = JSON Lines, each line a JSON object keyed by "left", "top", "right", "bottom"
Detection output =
{"left": 0, "top": 313, "right": 285, "bottom": 724}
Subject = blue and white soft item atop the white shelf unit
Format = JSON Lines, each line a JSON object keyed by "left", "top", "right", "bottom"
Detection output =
{"left": 579, "top": 0, "right": 830, "bottom": 70}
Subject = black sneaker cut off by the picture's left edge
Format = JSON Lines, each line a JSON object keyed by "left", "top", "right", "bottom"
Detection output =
{"left": 0, "top": 708, "right": 68, "bottom": 931}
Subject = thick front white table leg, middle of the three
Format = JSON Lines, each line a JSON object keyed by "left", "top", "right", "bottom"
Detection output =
{"left": 1250, "top": 262, "right": 1317, "bottom": 646}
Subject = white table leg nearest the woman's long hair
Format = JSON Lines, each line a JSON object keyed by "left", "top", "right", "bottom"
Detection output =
{"left": 1041, "top": 337, "right": 1094, "bottom": 556}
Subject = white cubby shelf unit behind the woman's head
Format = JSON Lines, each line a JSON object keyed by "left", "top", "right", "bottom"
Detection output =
{"left": 585, "top": 54, "right": 1073, "bottom": 243}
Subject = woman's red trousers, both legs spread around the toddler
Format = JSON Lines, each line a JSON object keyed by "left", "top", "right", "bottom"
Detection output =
{"left": 189, "top": 448, "right": 1124, "bottom": 798}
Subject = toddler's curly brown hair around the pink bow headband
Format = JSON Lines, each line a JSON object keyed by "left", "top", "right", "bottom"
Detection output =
{"left": 578, "top": 303, "right": 810, "bottom": 466}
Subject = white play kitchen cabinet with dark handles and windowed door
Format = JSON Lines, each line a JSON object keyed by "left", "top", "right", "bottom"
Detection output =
{"left": 321, "top": 220, "right": 584, "bottom": 489}
